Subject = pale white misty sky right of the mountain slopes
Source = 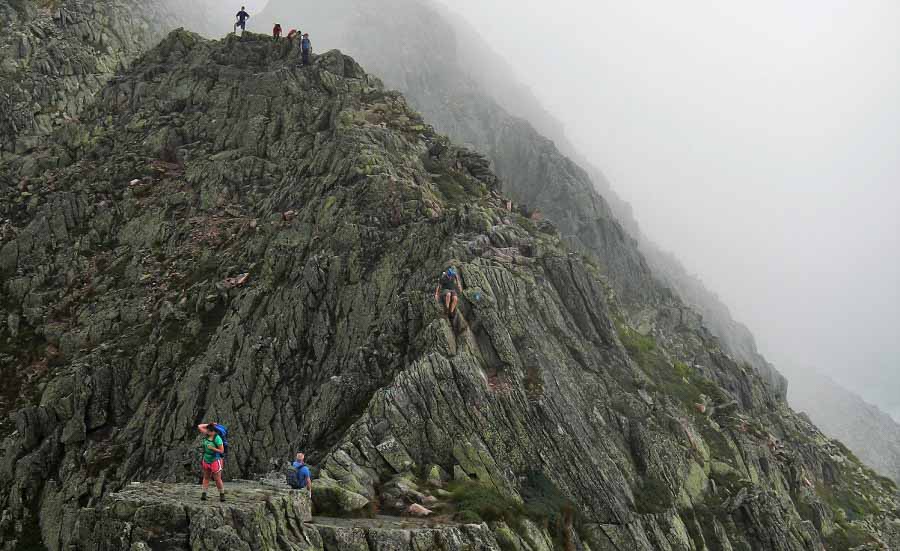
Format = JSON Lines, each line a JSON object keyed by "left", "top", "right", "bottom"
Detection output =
{"left": 430, "top": 0, "right": 900, "bottom": 419}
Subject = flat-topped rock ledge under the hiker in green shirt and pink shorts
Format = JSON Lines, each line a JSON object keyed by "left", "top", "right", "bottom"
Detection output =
{"left": 73, "top": 481, "right": 497, "bottom": 551}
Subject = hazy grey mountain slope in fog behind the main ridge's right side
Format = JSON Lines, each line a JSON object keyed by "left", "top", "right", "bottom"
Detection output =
{"left": 257, "top": 0, "right": 787, "bottom": 397}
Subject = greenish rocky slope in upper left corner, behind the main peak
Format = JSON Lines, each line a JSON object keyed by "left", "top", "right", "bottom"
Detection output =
{"left": 0, "top": 0, "right": 223, "bottom": 158}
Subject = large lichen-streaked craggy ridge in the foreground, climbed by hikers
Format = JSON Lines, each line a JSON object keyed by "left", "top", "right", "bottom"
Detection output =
{"left": 0, "top": 2, "right": 900, "bottom": 551}
